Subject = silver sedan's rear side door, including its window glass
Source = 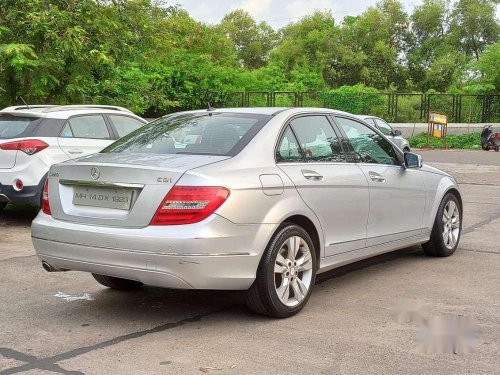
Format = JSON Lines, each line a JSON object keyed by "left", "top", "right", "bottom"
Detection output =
{"left": 277, "top": 114, "right": 369, "bottom": 256}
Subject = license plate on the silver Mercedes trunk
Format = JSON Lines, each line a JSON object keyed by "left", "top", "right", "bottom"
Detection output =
{"left": 73, "top": 186, "right": 132, "bottom": 211}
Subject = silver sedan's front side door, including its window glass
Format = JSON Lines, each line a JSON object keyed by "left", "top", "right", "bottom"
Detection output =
{"left": 335, "top": 116, "right": 425, "bottom": 246}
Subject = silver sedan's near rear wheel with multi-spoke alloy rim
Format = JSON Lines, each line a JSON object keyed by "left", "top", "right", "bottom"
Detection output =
{"left": 247, "top": 224, "right": 317, "bottom": 318}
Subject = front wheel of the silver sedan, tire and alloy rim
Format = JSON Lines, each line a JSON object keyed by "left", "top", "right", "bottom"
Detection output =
{"left": 422, "top": 193, "right": 462, "bottom": 257}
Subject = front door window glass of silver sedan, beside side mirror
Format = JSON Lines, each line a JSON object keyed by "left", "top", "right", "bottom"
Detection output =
{"left": 337, "top": 117, "right": 399, "bottom": 165}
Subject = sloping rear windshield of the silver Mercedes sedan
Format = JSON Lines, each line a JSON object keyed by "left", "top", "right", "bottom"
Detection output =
{"left": 102, "top": 113, "right": 270, "bottom": 156}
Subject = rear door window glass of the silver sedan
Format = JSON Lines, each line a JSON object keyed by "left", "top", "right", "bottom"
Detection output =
{"left": 290, "top": 116, "right": 345, "bottom": 162}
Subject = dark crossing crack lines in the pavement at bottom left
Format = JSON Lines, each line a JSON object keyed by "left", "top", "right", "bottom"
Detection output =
{"left": 0, "top": 307, "right": 227, "bottom": 375}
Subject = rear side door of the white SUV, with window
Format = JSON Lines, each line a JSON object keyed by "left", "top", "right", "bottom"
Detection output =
{"left": 58, "top": 114, "right": 113, "bottom": 159}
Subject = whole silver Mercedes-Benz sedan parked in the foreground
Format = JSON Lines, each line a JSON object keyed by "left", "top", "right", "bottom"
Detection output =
{"left": 32, "top": 108, "right": 462, "bottom": 317}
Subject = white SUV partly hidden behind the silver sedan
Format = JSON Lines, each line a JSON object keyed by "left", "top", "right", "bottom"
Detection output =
{"left": 0, "top": 105, "right": 147, "bottom": 211}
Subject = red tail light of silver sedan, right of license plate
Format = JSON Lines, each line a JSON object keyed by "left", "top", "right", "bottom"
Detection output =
{"left": 151, "top": 186, "right": 229, "bottom": 225}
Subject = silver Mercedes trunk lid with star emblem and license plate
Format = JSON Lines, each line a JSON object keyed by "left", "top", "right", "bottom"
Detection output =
{"left": 49, "top": 153, "right": 228, "bottom": 228}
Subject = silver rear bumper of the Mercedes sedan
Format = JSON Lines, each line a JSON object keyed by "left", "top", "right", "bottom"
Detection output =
{"left": 32, "top": 213, "right": 275, "bottom": 290}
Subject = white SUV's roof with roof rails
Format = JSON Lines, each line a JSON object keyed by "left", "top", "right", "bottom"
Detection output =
{"left": 0, "top": 104, "right": 139, "bottom": 119}
